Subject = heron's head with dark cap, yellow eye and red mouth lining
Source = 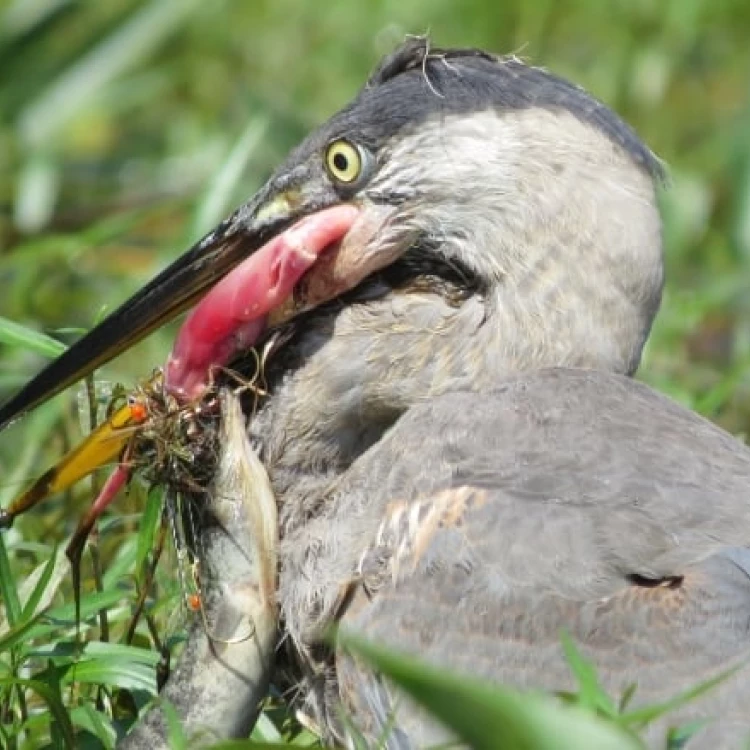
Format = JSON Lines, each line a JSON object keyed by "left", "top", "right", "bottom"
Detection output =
{"left": 0, "top": 39, "right": 662, "bottom": 432}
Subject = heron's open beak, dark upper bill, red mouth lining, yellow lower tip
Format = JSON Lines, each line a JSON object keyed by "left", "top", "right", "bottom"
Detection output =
{"left": 0, "top": 193, "right": 360, "bottom": 528}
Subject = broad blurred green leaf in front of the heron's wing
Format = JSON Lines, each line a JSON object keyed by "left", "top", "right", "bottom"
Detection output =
{"left": 338, "top": 635, "right": 642, "bottom": 750}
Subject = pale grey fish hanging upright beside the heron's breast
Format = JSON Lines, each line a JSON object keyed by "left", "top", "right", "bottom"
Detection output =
{"left": 119, "top": 387, "right": 278, "bottom": 750}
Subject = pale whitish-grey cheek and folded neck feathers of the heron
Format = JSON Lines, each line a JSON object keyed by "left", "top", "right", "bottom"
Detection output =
{"left": 251, "top": 109, "right": 662, "bottom": 530}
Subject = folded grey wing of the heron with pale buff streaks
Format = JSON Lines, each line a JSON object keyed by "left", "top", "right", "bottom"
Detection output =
{"left": 329, "top": 370, "right": 750, "bottom": 747}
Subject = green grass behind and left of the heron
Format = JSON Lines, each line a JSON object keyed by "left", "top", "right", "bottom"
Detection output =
{"left": 0, "top": 0, "right": 750, "bottom": 747}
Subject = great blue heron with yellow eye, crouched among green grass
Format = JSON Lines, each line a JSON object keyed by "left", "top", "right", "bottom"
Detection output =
{"left": 0, "top": 40, "right": 750, "bottom": 748}
